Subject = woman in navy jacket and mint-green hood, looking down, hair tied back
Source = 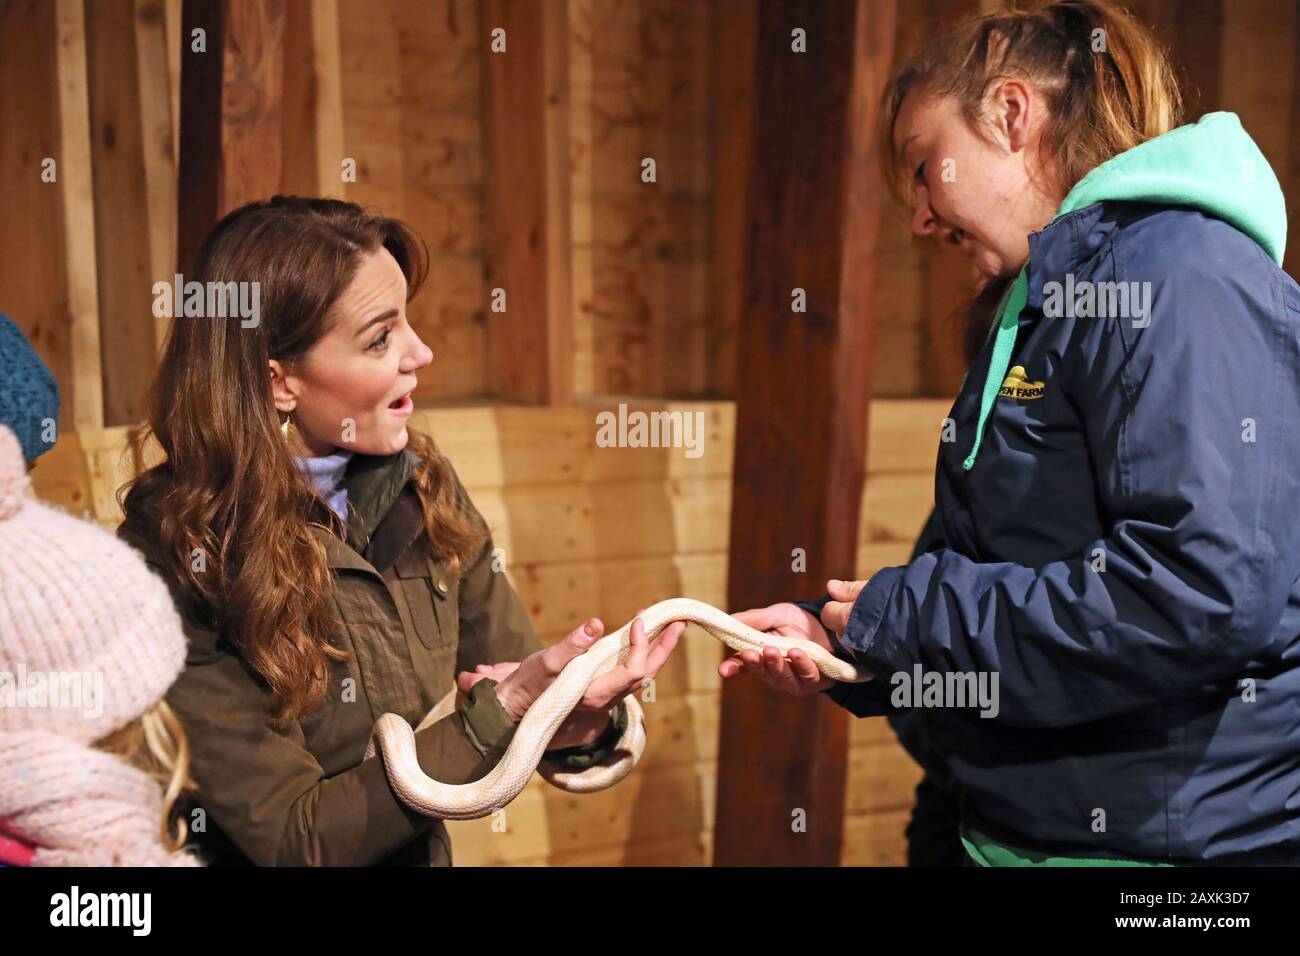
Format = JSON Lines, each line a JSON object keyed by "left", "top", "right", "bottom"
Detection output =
{"left": 722, "top": 1, "right": 1300, "bottom": 865}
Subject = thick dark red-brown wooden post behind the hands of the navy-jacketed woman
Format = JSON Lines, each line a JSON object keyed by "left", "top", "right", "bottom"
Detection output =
{"left": 714, "top": 0, "right": 896, "bottom": 865}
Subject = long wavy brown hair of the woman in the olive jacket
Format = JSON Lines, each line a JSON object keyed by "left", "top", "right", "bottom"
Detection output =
{"left": 117, "top": 196, "right": 482, "bottom": 723}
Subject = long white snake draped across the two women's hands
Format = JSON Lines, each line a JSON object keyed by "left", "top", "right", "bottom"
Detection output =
{"left": 365, "top": 597, "right": 870, "bottom": 819}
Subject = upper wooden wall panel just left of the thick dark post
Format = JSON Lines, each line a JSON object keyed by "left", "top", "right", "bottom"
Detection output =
{"left": 569, "top": 0, "right": 725, "bottom": 395}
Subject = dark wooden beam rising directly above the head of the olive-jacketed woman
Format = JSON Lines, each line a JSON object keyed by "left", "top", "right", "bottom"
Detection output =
{"left": 177, "top": 0, "right": 285, "bottom": 271}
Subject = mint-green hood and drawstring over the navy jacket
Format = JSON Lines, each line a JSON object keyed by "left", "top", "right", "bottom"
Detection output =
{"left": 962, "top": 113, "right": 1287, "bottom": 471}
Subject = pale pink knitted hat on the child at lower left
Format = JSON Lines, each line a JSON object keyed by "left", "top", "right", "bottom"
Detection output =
{"left": 0, "top": 425, "right": 186, "bottom": 744}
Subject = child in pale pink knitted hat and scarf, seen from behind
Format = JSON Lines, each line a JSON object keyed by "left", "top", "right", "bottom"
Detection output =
{"left": 0, "top": 425, "right": 198, "bottom": 866}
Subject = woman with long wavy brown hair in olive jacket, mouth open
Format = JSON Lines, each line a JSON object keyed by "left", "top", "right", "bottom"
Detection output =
{"left": 120, "top": 196, "right": 683, "bottom": 865}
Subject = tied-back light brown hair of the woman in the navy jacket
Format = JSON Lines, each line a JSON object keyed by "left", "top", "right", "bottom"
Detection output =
{"left": 876, "top": 0, "right": 1183, "bottom": 343}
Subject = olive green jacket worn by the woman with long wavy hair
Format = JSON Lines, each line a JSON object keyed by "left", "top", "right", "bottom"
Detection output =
{"left": 120, "top": 450, "right": 627, "bottom": 866}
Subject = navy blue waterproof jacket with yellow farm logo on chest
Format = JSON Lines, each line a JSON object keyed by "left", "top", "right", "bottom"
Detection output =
{"left": 801, "top": 114, "right": 1300, "bottom": 864}
